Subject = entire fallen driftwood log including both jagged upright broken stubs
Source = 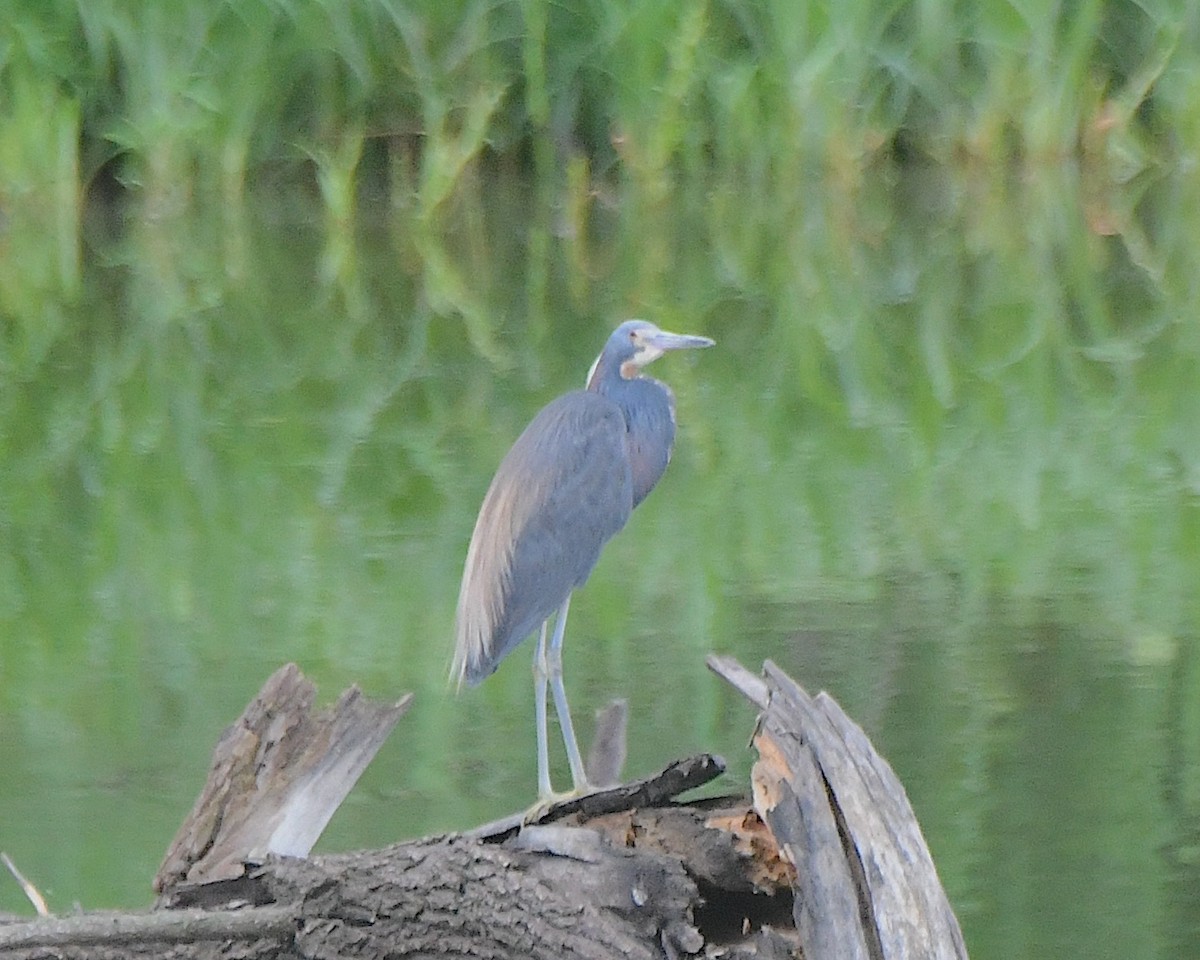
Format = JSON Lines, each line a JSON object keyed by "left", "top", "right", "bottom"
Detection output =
{"left": 0, "top": 659, "right": 966, "bottom": 960}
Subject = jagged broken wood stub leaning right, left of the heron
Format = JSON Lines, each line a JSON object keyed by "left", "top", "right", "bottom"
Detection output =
{"left": 154, "top": 664, "right": 412, "bottom": 893}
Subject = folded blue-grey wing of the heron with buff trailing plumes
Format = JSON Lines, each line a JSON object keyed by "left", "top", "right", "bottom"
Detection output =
{"left": 454, "top": 390, "right": 632, "bottom": 683}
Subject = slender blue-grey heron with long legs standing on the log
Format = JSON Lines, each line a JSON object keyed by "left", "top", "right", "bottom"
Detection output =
{"left": 451, "top": 320, "right": 713, "bottom": 803}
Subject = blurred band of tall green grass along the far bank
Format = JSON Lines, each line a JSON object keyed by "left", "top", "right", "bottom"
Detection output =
{"left": 0, "top": 0, "right": 1200, "bottom": 214}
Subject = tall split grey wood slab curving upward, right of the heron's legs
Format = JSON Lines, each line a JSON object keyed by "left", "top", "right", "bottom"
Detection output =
{"left": 709, "top": 659, "right": 966, "bottom": 960}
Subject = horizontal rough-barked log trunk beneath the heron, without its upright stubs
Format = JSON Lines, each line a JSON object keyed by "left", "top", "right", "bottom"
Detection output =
{"left": 0, "top": 800, "right": 791, "bottom": 960}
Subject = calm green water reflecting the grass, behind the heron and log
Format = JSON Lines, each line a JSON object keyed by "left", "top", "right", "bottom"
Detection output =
{"left": 0, "top": 160, "right": 1200, "bottom": 958}
